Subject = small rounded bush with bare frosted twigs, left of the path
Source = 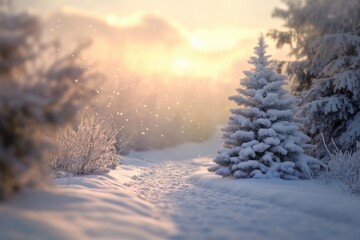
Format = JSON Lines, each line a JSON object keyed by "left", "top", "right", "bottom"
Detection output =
{"left": 50, "top": 117, "right": 119, "bottom": 175}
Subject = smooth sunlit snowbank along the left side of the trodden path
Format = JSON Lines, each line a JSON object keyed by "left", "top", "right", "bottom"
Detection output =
{"left": 0, "top": 159, "right": 175, "bottom": 240}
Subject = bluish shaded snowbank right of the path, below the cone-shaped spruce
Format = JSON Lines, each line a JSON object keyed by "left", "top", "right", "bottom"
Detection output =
{"left": 191, "top": 158, "right": 360, "bottom": 239}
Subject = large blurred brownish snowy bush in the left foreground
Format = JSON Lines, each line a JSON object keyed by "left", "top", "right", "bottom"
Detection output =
{"left": 0, "top": 1, "right": 93, "bottom": 198}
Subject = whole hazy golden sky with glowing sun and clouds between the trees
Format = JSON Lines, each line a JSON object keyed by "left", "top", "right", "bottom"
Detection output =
{"left": 15, "top": 0, "right": 287, "bottom": 146}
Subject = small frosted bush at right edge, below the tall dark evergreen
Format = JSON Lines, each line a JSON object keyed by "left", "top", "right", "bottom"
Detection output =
{"left": 324, "top": 142, "right": 360, "bottom": 194}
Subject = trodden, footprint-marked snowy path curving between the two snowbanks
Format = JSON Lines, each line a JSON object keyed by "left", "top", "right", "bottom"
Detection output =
{"left": 123, "top": 157, "right": 360, "bottom": 239}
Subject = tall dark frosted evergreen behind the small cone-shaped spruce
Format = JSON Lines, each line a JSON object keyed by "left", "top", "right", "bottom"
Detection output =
{"left": 270, "top": 0, "right": 360, "bottom": 158}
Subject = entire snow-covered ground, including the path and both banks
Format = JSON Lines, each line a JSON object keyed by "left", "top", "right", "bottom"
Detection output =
{"left": 0, "top": 129, "right": 360, "bottom": 240}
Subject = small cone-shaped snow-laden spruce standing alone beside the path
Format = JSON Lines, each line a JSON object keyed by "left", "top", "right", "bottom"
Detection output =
{"left": 209, "top": 37, "right": 319, "bottom": 179}
